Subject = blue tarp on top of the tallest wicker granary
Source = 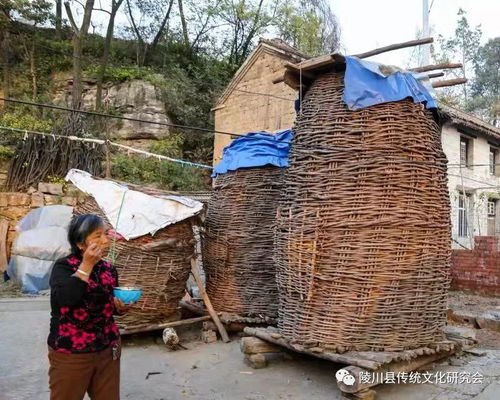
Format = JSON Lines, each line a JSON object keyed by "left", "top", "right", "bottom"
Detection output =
{"left": 343, "top": 57, "right": 437, "bottom": 110}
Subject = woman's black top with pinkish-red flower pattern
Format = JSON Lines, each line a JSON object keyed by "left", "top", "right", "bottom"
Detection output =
{"left": 47, "top": 255, "right": 120, "bottom": 354}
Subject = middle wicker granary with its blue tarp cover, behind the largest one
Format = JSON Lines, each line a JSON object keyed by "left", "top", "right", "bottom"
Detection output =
{"left": 203, "top": 131, "right": 291, "bottom": 318}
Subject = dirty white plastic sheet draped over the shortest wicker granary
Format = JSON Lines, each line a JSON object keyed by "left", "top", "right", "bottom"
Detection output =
{"left": 66, "top": 169, "right": 203, "bottom": 240}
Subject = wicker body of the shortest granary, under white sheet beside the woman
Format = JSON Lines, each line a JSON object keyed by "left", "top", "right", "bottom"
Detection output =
{"left": 68, "top": 172, "right": 200, "bottom": 330}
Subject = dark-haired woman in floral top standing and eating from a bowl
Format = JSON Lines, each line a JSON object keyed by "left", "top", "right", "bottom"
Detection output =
{"left": 48, "top": 215, "right": 126, "bottom": 400}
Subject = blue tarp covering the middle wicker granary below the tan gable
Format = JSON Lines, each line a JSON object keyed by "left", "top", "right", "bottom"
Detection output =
{"left": 212, "top": 129, "right": 292, "bottom": 177}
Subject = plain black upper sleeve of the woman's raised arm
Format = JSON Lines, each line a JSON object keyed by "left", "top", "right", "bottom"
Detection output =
{"left": 50, "top": 259, "right": 87, "bottom": 307}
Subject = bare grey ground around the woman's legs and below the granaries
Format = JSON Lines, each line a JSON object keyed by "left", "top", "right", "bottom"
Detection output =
{"left": 0, "top": 298, "right": 500, "bottom": 400}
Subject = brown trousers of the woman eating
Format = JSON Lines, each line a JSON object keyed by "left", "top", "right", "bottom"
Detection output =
{"left": 49, "top": 348, "right": 120, "bottom": 400}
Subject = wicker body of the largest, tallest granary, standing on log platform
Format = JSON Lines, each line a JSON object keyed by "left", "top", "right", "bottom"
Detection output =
{"left": 276, "top": 60, "right": 450, "bottom": 352}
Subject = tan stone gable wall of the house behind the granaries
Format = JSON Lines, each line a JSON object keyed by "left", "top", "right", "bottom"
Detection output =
{"left": 214, "top": 52, "right": 297, "bottom": 164}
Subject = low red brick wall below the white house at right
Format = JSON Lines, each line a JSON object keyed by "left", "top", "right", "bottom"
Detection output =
{"left": 451, "top": 236, "right": 500, "bottom": 296}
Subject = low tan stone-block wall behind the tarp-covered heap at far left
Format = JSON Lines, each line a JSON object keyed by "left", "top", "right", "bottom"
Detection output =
{"left": 0, "top": 192, "right": 85, "bottom": 256}
